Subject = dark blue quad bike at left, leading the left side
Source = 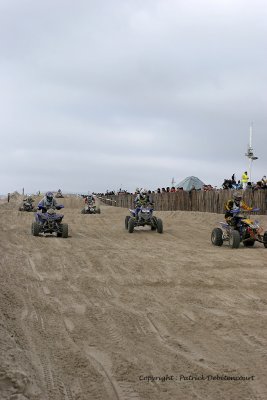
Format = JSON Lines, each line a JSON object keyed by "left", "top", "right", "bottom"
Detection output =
{"left": 32, "top": 205, "right": 68, "bottom": 238}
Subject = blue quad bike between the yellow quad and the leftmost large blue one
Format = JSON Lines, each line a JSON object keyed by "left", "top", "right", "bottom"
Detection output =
{"left": 125, "top": 205, "right": 163, "bottom": 233}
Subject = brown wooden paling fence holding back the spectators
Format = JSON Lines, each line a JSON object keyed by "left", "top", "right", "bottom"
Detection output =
{"left": 100, "top": 189, "right": 267, "bottom": 215}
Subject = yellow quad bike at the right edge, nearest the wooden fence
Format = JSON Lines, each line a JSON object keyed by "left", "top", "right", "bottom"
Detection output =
{"left": 211, "top": 208, "right": 267, "bottom": 249}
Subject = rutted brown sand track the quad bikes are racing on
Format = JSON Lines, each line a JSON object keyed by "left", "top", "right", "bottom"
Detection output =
{"left": 0, "top": 197, "right": 267, "bottom": 400}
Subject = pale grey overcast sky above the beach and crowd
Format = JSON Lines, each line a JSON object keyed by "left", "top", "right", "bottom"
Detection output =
{"left": 0, "top": 0, "right": 267, "bottom": 193}
